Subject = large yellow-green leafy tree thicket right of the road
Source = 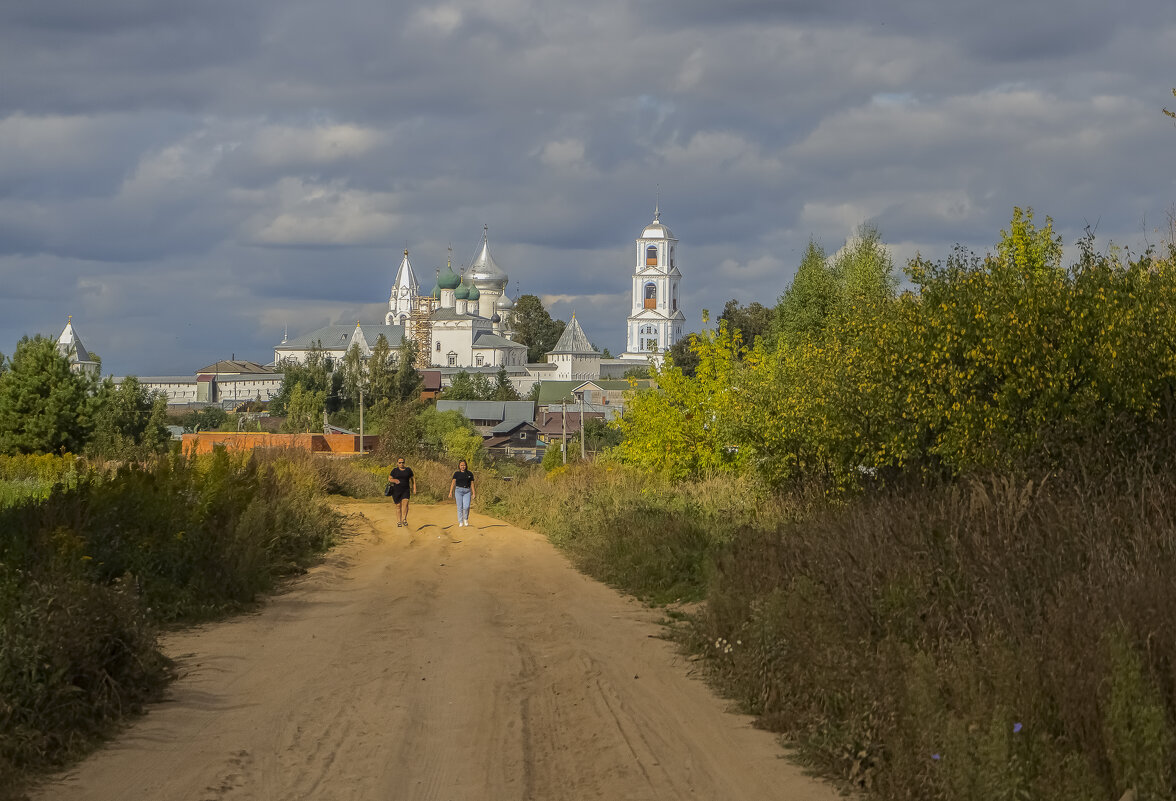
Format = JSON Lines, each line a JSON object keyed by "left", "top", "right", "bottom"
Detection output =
{"left": 617, "top": 208, "right": 1176, "bottom": 487}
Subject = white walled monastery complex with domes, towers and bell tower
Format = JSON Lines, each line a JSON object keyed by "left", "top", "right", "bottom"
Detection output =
{"left": 59, "top": 208, "right": 686, "bottom": 403}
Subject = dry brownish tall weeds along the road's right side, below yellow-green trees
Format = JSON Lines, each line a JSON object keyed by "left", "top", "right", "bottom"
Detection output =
{"left": 687, "top": 460, "right": 1176, "bottom": 801}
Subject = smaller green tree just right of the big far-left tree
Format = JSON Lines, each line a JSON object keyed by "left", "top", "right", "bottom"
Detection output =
{"left": 86, "top": 375, "right": 170, "bottom": 459}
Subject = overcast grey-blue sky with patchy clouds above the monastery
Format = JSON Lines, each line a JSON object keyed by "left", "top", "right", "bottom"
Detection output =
{"left": 0, "top": 0, "right": 1176, "bottom": 375}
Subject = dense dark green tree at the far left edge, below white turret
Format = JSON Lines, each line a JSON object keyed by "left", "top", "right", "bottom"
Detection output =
{"left": 0, "top": 336, "right": 95, "bottom": 454}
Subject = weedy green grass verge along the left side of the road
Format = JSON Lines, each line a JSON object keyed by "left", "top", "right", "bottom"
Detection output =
{"left": 0, "top": 452, "right": 348, "bottom": 799}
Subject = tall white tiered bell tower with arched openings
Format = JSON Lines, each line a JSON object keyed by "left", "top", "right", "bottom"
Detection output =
{"left": 621, "top": 206, "right": 686, "bottom": 362}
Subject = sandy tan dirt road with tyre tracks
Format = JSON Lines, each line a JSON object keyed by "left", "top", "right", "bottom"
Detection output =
{"left": 35, "top": 505, "right": 838, "bottom": 801}
